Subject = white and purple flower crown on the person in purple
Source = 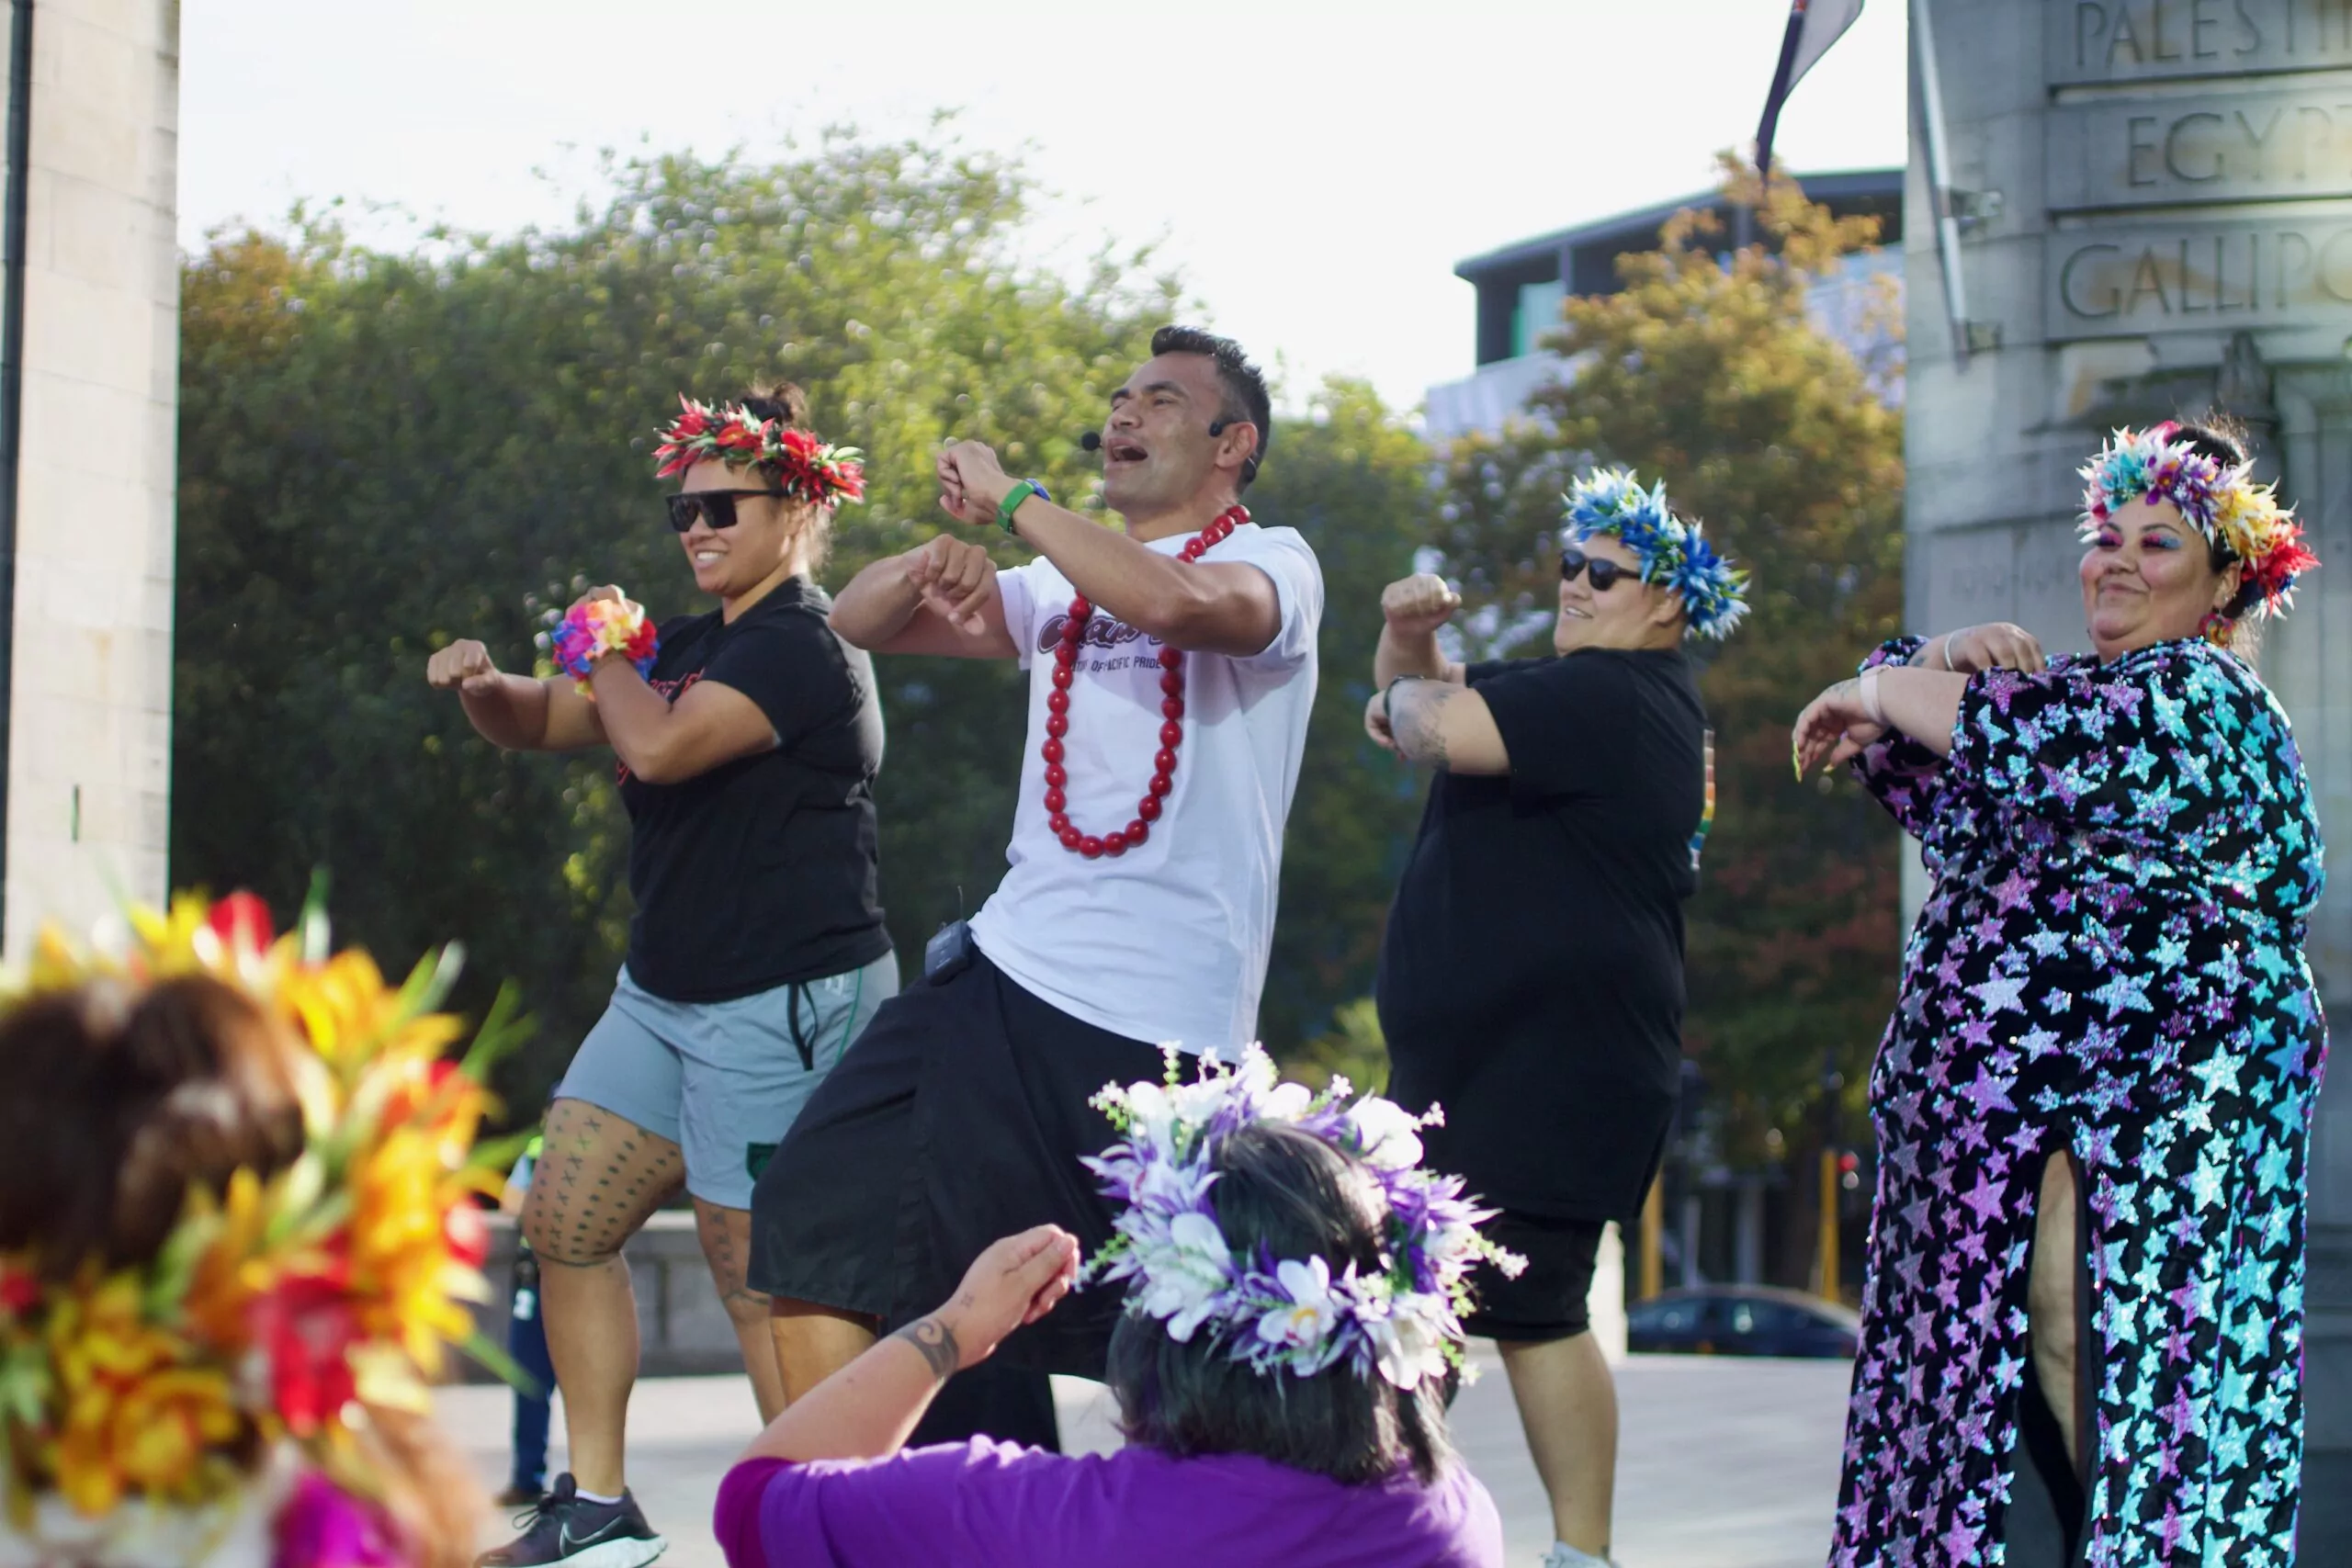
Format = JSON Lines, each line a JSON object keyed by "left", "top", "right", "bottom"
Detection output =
{"left": 1084, "top": 1046, "right": 1526, "bottom": 1389}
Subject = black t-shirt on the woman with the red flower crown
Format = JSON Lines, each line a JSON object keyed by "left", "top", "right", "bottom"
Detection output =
{"left": 621, "top": 576, "right": 889, "bottom": 1001}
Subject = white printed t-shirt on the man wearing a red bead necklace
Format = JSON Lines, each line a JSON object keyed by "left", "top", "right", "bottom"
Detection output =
{"left": 971, "top": 525, "right": 1324, "bottom": 1054}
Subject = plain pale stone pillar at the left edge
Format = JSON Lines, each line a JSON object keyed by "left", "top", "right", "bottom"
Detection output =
{"left": 0, "top": 0, "right": 179, "bottom": 957}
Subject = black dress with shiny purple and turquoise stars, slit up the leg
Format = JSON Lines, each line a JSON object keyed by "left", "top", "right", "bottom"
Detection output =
{"left": 1830, "top": 639, "right": 2326, "bottom": 1568}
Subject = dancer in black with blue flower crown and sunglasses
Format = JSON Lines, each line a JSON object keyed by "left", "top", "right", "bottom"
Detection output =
{"left": 1364, "top": 468, "right": 1747, "bottom": 1568}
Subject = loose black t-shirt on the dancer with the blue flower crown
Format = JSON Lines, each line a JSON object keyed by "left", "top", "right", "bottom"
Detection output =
{"left": 1378, "top": 649, "right": 1708, "bottom": 1220}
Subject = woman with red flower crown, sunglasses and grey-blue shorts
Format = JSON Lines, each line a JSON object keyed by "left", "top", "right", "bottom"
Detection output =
{"left": 428, "top": 386, "right": 899, "bottom": 1568}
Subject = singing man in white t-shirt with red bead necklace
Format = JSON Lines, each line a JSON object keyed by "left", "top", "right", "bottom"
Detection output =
{"left": 751, "top": 327, "right": 1322, "bottom": 1437}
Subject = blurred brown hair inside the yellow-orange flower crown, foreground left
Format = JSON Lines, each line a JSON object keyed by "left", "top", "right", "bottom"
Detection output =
{"left": 0, "top": 976, "right": 301, "bottom": 1279}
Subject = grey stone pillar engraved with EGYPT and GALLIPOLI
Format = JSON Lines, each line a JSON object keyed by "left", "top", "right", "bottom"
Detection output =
{"left": 1905, "top": 0, "right": 2352, "bottom": 1561}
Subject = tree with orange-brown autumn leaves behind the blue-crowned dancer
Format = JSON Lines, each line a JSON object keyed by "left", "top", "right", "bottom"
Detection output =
{"left": 1440, "top": 165, "right": 1903, "bottom": 1259}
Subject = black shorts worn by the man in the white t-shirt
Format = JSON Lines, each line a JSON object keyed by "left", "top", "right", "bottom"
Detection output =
{"left": 751, "top": 952, "right": 1162, "bottom": 1378}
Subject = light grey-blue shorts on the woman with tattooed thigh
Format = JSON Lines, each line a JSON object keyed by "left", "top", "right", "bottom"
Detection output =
{"left": 555, "top": 952, "right": 899, "bottom": 1208}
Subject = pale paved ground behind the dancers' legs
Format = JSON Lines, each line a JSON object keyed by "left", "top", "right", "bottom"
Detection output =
{"left": 442, "top": 1354, "right": 1849, "bottom": 1568}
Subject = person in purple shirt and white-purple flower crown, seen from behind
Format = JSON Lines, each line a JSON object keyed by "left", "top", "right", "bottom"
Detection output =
{"left": 715, "top": 1048, "right": 1515, "bottom": 1568}
